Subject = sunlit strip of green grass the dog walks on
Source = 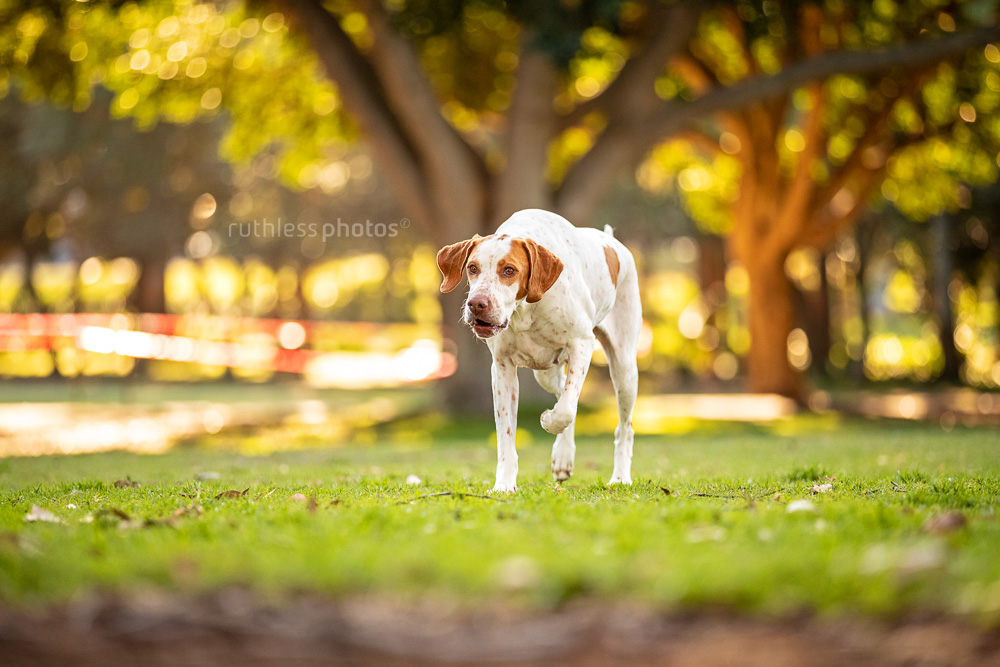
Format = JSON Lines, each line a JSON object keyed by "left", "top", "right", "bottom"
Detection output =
{"left": 0, "top": 419, "right": 1000, "bottom": 624}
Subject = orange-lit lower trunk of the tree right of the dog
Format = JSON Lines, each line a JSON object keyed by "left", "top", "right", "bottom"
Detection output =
{"left": 744, "top": 249, "right": 805, "bottom": 403}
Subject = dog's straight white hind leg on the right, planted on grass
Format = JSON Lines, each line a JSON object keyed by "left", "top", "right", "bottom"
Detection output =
{"left": 594, "top": 270, "right": 642, "bottom": 484}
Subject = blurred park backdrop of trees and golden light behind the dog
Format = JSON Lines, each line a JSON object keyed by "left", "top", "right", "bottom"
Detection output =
{"left": 0, "top": 0, "right": 1000, "bottom": 455}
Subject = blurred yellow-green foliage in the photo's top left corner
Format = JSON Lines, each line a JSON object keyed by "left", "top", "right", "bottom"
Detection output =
{"left": 0, "top": 0, "right": 355, "bottom": 193}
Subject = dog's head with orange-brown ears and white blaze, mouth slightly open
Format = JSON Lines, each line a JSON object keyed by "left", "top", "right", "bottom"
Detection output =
{"left": 437, "top": 234, "right": 563, "bottom": 338}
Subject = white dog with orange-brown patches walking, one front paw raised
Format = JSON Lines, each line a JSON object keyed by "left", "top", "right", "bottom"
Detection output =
{"left": 437, "top": 209, "right": 642, "bottom": 492}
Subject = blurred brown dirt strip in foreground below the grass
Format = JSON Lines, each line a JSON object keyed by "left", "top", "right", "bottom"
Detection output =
{"left": 0, "top": 591, "right": 1000, "bottom": 667}
